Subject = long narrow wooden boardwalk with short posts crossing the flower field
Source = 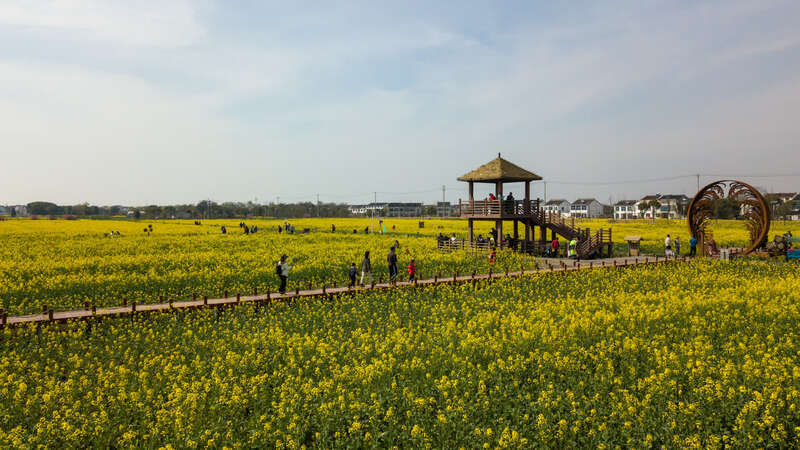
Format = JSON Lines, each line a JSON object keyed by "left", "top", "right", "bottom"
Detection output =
{"left": 0, "top": 256, "right": 686, "bottom": 327}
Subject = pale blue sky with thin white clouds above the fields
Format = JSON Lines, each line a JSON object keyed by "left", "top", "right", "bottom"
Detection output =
{"left": 0, "top": 0, "right": 800, "bottom": 204}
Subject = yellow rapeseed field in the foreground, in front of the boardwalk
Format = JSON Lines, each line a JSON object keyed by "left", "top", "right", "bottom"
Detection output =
{"left": 0, "top": 256, "right": 800, "bottom": 448}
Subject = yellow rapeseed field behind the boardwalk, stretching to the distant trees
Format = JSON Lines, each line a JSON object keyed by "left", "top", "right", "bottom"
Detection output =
{"left": 0, "top": 218, "right": 760, "bottom": 315}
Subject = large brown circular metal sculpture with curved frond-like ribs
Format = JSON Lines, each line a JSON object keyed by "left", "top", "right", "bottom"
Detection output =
{"left": 687, "top": 180, "right": 770, "bottom": 254}
